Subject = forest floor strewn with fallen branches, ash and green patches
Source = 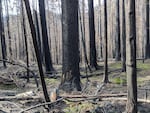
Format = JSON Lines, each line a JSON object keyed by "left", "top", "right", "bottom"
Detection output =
{"left": 0, "top": 60, "right": 150, "bottom": 113}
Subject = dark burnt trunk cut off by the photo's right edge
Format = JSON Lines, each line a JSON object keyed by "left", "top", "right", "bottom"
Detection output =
{"left": 145, "top": 0, "right": 150, "bottom": 58}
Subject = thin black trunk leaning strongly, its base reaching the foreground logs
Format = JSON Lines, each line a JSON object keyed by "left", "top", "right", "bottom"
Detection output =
{"left": 24, "top": 0, "right": 50, "bottom": 102}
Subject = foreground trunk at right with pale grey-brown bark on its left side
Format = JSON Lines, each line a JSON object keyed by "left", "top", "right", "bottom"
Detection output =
{"left": 126, "top": 0, "right": 137, "bottom": 113}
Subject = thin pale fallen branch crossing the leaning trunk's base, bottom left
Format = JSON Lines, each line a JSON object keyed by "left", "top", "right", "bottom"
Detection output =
{"left": 20, "top": 98, "right": 63, "bottom": 113}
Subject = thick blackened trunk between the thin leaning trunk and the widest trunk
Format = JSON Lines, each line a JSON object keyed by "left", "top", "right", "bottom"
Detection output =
{"left": 39, "top": 0, "right": 54, "bottom": 73}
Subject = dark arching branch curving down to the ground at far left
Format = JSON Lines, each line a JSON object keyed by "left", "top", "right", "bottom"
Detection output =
{"left": 0, "top": 59, "right": 39, "bottom": 88}
